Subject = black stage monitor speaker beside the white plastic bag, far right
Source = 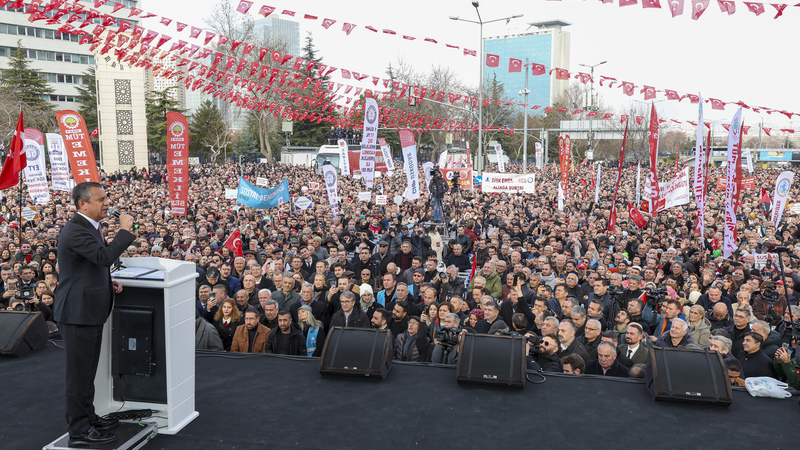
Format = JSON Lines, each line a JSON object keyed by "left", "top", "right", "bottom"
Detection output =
{"left": 645, "top": 347, "right": 731, "bottom": 406}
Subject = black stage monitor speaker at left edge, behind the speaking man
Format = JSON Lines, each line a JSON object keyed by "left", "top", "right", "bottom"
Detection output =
{"left": 0, "top": 311, "right": 49, "bottom": 356}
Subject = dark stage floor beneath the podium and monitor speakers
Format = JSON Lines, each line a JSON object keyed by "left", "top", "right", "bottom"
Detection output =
{"left": 0, "top": 342, "right": 800, "bottom": 450}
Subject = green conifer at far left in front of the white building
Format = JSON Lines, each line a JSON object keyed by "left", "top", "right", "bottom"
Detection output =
{"left": 0, "top": 41, "right": 55, "bottom": 130}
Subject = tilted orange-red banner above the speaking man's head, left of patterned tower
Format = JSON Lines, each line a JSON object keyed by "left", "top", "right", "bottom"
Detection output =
{"left": 56, "top": 109, "right": 100, "bottom": 184}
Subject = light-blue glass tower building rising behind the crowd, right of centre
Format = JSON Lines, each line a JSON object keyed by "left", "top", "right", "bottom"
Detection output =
{"left": 481, "top": 20, "right": 571, "bottom": 111}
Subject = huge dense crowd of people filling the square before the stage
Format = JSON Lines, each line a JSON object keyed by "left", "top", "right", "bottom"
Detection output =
{"left": 0, "top": 152, "right": 800, "bottom": 388}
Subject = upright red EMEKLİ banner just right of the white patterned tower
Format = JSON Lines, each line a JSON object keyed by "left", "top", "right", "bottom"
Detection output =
{"left": 167, "top": 111, "right": 189, "bottom": 216}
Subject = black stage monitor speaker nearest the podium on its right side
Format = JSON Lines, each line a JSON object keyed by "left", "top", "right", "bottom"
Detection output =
{"left": 319, "top": 327, "right": 392, "bottom": 379}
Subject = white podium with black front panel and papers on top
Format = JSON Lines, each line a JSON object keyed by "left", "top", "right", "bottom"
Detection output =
{"left": 94, "top": 258, "right": 199, "bottom": 434}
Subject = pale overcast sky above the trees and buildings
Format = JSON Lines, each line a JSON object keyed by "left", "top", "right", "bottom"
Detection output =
{"left": 143, "top": 0, "right": 800, "bottom": 131}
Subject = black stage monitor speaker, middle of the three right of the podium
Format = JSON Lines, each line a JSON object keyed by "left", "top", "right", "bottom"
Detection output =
{"left": 456, "top": 333, "right": 525, "bottom": 389}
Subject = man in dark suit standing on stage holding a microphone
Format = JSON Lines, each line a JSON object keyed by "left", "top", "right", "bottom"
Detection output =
{"left": 54, "top": 182, "right": 136, "bottom": 447}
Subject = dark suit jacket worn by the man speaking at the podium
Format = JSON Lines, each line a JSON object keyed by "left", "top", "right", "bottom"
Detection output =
{"left": 54, "top": 213, "right": 136, "bottom": 325}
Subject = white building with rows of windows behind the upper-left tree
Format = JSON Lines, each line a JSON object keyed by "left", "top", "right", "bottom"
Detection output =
{"left": 0, "top": 0, "right": 140, "bottom": 110}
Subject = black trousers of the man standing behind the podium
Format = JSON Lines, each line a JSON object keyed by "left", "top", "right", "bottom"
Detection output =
{"left": 59, "top": 324, "right": 103, "bottom": 436}
